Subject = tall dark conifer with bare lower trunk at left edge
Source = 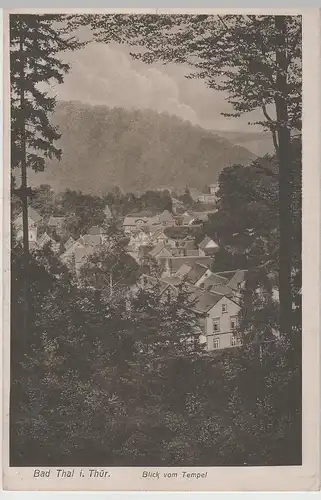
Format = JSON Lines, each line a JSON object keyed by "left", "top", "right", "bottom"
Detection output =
{"left": 10, "top": 14, "right": 82, "bottom": 332}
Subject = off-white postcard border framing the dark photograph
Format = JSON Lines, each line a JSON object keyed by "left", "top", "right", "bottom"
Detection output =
{"left": 3, "top": 9, "right": 321, "bottom": 491}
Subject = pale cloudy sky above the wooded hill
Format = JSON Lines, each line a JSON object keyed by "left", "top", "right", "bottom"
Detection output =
{"left": 55, "top": 42, "right": 268, "bottom": 132}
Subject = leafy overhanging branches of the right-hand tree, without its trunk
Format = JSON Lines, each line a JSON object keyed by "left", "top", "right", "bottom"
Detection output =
{"left": 76, "top": 14, "right": 302, "bottom": 135}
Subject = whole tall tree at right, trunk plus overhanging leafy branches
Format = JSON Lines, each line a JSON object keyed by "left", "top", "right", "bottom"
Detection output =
{"left": 80, "top": 14, "right": 302, "bottom": 335}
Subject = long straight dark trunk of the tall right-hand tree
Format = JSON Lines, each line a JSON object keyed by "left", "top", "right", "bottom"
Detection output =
{"left": 275, "top": 16, "right": 292, "bottom": 336}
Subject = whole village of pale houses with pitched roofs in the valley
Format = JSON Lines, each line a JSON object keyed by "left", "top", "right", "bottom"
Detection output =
{"left": 14, "top": 185, "right": 250, "bottom": 352}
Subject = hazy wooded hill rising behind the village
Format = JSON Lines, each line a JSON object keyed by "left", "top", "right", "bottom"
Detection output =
{"left": 29, "top": 102, "right": 255, "bottom": 194}
